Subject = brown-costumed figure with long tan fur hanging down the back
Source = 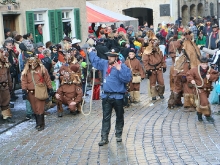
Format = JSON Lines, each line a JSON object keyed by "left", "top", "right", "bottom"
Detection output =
{"left": 173, "top": 30, "right": 201, "bottom": 112}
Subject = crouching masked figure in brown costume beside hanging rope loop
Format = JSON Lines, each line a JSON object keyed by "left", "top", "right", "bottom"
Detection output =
{"left": 55, "top": 69, "right": 83, "bottom": 117}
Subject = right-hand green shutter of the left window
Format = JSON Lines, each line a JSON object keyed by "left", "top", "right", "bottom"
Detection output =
{"left": 48, "top": 10, "right": 57, "bottom": 44}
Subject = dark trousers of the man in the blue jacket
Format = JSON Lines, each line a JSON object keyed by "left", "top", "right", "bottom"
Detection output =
{"left": 101, "top": 98, "right": 124, "bottom": 139}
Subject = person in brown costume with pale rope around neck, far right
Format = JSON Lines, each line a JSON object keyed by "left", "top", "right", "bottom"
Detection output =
{"left": 187, "top": 57, "right": 219, "bottom": 123}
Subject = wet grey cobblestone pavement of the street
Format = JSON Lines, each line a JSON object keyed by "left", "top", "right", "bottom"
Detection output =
{"left": 0, "top": 57, "right": 220, "bottom": 165}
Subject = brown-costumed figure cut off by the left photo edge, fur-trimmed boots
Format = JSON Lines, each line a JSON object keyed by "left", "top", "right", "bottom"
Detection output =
{"left": 0, "top": 49, "right": 13, "bottom": 122}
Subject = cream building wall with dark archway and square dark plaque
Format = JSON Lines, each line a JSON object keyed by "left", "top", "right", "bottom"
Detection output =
{"left": 89, "top": 0, "right": 178, "bottom": 28}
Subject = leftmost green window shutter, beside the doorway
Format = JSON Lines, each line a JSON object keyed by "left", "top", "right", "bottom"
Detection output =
{"left": 26, "top": 11, "right": 35, "bottom": 42}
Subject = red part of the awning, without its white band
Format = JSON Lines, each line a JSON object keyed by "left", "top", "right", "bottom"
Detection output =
{"left": 86, "top": 6, "right": 118, "bottom": 23}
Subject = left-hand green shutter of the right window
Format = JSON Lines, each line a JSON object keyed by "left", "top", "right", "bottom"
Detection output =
{"left": 55, "top": 10, "right": 63, "bottom": 43}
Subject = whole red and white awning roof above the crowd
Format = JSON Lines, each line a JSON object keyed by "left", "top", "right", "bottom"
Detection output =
{"left": 86, "top": 2, "right": 137, "bottom": 23}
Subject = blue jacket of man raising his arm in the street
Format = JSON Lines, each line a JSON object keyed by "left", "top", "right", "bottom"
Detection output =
{"left": 89, "top": 51, "right": 132, "bottom": 99}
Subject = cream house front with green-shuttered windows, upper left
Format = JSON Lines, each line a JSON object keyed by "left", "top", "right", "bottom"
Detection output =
{"left": 0, "top": 0, "right": 87, "bottom": 44}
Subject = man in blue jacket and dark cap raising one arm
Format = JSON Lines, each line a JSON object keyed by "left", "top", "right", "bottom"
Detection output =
{"left": 88, "top": 48, "right": 132, "bottom": 146}
